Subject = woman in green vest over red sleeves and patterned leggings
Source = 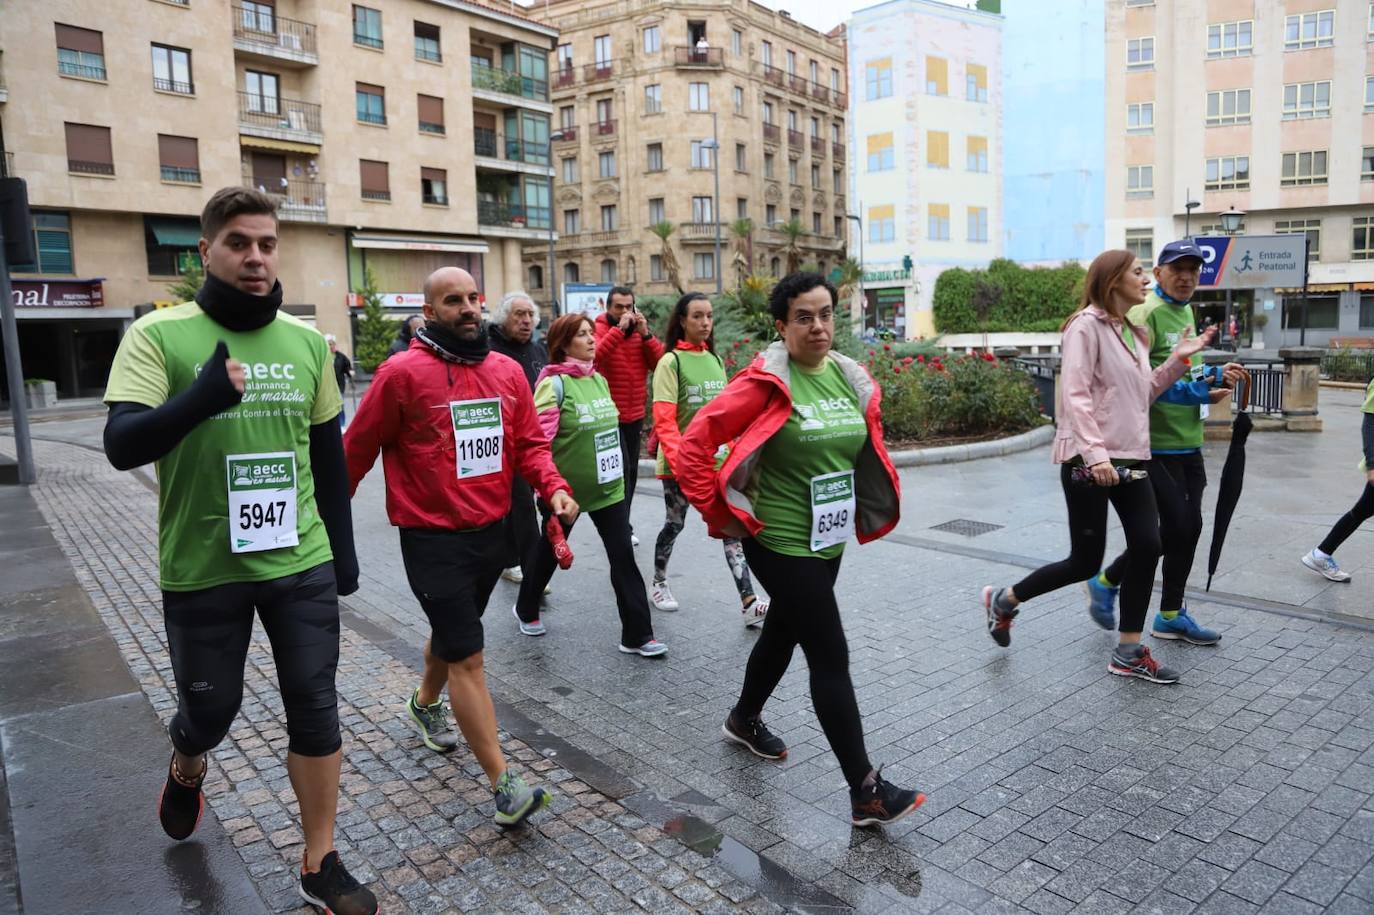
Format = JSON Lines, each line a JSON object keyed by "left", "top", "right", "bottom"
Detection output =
{"left": 651, "top": 293, "right": 768, "bottom": 629}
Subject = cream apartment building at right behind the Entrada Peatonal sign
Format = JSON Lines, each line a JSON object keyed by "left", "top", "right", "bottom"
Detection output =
{"left": 1106, "top": 0, "right": 1374, "bottom": 346}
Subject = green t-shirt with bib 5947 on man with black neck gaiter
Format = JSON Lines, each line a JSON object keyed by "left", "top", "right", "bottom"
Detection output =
{"left": 104, "top": 302, "right": 342, "bottom": 591}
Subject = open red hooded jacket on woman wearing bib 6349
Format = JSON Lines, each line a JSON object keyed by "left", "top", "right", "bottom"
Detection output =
{"left": 676, "top": 342, "right": 901, "bottom": 543}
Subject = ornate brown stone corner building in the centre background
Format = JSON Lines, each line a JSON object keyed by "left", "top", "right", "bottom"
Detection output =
{"left": 525, "top": 0, "right": 848, "bottom": 297}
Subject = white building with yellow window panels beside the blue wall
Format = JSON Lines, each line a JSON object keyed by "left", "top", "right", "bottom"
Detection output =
{"left": 848, "top": 0, "right": 1003, "bottom": 339}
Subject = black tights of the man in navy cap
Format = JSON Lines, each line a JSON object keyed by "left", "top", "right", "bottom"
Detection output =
{"left": 1104, "top": 451, "right": 1206, "bottom": 611}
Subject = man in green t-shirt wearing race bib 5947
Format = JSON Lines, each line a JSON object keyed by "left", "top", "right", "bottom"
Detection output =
{"left": 104, "top": 187, "right": 376, "bottom": 915}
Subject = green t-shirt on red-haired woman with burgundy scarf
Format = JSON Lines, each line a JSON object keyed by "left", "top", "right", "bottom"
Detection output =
{"left": 534, "top": 372, "right": 625, "bottom": 511}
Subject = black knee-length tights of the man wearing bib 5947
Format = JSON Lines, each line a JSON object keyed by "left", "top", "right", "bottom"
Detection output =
{"left": 162, "top": 562, "right": 342, "bottom": 756}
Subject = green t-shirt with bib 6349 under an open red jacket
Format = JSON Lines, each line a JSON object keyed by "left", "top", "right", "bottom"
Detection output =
{"left": 746, "top": 357, "right": 868, "bottom": 559}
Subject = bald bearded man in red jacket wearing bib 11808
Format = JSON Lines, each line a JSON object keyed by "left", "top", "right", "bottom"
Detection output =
{"left": 344, "top": 267, "right": 577, "bottom": 826}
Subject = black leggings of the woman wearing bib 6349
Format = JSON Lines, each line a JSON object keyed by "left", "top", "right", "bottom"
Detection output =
{"left": 735, "top": 537, "right": 872, "bottom": 791}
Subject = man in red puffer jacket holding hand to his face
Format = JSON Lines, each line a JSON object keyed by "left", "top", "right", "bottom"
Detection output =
{"left": 595, "top": 286, "right": 664, "bottom": 547}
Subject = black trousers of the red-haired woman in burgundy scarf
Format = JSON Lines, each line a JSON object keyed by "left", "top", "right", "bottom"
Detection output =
{"left": 515, "top": 500, "right": 654, "bottom": 648}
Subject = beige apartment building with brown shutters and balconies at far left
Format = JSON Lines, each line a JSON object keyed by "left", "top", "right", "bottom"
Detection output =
{"left": 0, "top": 0, "right": 556, "bottom": 396}
